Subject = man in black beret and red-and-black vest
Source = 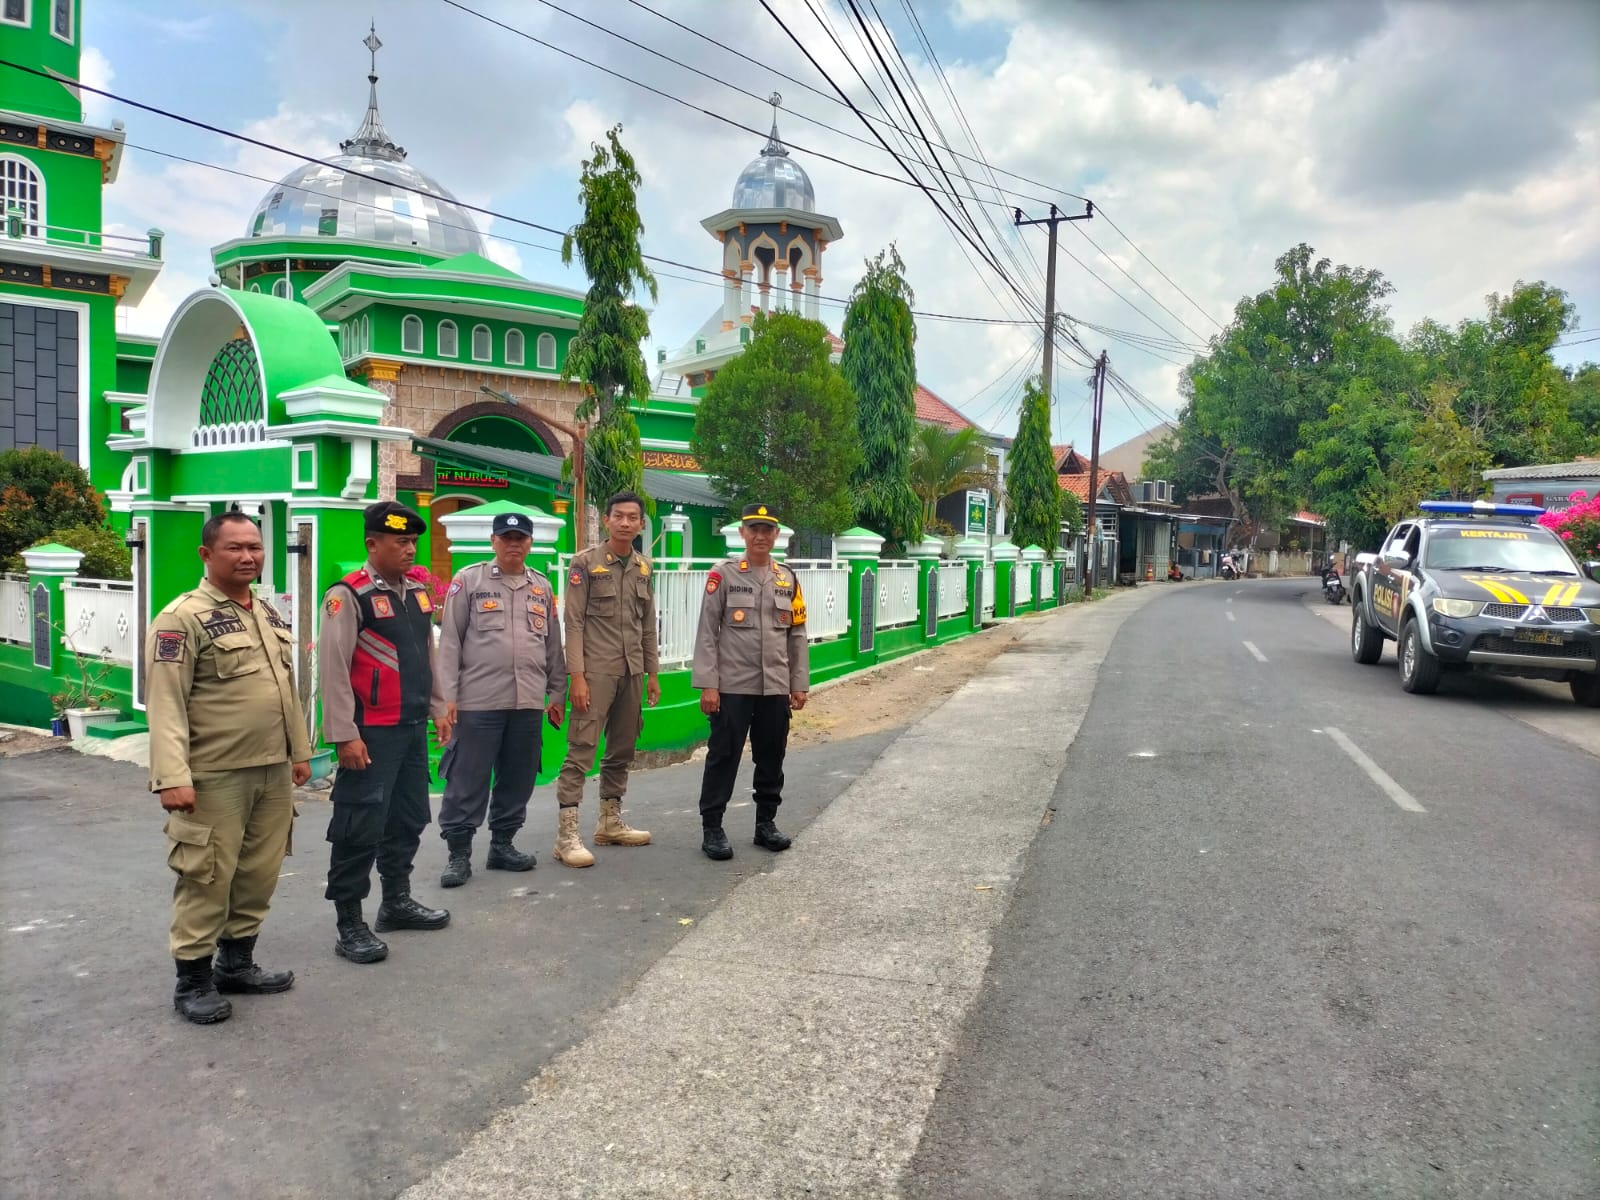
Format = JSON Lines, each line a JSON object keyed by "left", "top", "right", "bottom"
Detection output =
{"left": 320, "top": 501, "right": 450, "bottom": 963}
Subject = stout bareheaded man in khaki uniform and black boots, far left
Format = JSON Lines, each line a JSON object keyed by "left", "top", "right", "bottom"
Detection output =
{"left": 144, "top": 512, "right": 310, "bottom": 1026}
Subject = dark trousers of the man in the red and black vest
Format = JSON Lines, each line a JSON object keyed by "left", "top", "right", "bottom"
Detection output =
{"left": 323, "top": 723, "right": 432, "bottom": 901}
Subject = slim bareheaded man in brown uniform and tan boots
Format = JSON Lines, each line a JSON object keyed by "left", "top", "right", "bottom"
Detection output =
{"left": 555, "top": 491, "right": 661, "bottom": 867}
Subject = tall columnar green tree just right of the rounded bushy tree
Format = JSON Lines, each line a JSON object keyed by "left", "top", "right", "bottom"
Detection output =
{"left": 838, "top": 245, "right": 925, "bottom": 549}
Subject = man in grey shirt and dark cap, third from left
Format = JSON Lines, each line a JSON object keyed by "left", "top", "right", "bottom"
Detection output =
{"left": 434, "top": 512, "right": 566, "bottom": 888}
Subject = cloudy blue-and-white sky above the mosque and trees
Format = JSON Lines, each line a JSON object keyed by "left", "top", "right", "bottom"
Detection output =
{"left": 85, "top": 0, "right": 1600, "bottom": 445}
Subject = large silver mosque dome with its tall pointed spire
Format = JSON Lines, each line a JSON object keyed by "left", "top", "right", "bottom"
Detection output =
{"left": 245, "top": 29, "right": 485, "bottom": 258}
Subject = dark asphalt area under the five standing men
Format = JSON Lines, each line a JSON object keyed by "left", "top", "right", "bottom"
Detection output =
{"left": 0, "top": 734, "right": 891, "bottom": 1200}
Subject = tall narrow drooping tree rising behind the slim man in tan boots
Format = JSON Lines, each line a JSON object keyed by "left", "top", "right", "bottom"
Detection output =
{"left": 562, "top": 125, "right": 656, "bottom": 539}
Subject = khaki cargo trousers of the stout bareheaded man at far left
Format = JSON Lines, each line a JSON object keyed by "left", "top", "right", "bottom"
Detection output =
{"left": 166, "top": 762, "right": 294, "bottom": 960}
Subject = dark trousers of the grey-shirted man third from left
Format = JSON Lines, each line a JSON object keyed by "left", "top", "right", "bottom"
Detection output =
{"left": 438, "top": 709, "right": 544, "bottom": 838}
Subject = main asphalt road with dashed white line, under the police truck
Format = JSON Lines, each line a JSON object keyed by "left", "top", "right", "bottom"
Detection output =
{"left": 901, "top": 581, "right": 1600, "bottom": 1200}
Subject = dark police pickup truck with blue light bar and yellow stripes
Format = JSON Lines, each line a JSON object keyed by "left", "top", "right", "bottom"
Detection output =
{"left": 1350, "top": 501, "right": 1600, "bottom": 707}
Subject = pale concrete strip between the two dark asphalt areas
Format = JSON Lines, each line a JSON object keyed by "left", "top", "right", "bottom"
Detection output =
{"left": 403, "top": 589, "right": 1162, "bottom": 1200}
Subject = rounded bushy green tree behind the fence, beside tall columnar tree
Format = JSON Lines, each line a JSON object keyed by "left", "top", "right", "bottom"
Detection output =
{"left": 693, "top": 312, "right": 861, "bottom": 533}
